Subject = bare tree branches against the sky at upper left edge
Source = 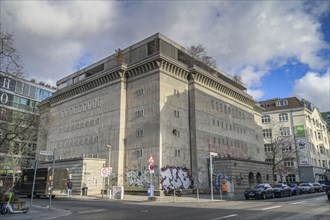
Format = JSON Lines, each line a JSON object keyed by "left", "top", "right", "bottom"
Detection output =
{"left": 0, "top": 24, "right": 23, "bottom": 77}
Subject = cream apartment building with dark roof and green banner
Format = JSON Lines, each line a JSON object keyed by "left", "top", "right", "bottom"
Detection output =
{"left": 259, "top": 97, "right": 330, "bottom": 182}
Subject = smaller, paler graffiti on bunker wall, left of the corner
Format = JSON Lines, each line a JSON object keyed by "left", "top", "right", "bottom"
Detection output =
{"left": 126, "top": 170, "right": 150, "bottom": 188}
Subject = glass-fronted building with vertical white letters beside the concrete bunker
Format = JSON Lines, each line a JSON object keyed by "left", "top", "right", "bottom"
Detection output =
{"left": 0, "top": 73, "right": 56, "bottom": 173}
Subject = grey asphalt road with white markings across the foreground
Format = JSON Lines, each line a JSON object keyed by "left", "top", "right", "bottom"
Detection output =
{"left": 17, "top": 193, "right": 330, "bottom": 220}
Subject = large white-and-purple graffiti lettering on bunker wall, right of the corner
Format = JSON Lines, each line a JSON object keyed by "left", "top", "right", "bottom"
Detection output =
{"left": 161, "top": 166, "right": 193, "bottom": 189}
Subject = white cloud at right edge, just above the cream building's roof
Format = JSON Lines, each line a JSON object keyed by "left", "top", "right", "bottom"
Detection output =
{"left": 293, "top": 69, "right": 330, "bottom": 111}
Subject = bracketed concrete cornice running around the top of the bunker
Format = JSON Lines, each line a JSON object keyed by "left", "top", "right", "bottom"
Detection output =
{"left": 40, "top": 53, "right": 260, "bottom": 110}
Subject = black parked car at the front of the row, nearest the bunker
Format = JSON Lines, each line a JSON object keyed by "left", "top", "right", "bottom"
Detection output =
{"left": 244, "top": 183, "right": 275, "bottom": 199}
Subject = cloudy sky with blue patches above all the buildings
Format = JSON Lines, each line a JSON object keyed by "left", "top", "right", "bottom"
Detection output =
{"left": 0, "top": 0, "right": 330, "bottom": 111}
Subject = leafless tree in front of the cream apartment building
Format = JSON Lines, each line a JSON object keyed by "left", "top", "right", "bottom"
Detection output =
{"left": 263, "top": 120, "right": 297, "bottom": 182}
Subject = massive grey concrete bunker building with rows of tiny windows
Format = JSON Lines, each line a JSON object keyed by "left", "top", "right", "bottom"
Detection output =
{"left": 38, "top": 33, "right": 270, "bottom": 192}
